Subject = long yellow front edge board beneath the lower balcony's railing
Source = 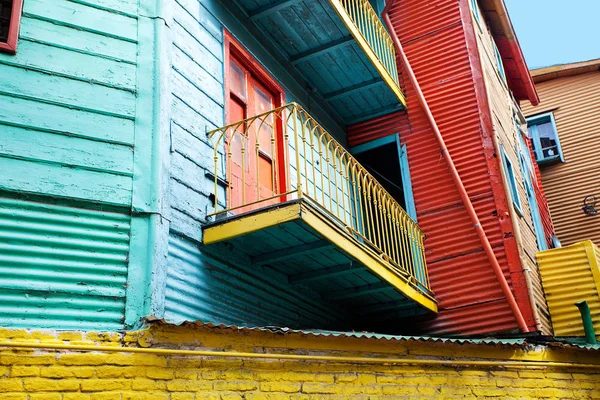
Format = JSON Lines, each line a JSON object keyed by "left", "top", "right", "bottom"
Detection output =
{"left": 301, "top": 203, "right": 438, "bottom": 313}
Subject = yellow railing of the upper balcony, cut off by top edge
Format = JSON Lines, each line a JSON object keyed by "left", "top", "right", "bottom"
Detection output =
{"left": 329, "top": 0, "right": 406, "bottom": 106}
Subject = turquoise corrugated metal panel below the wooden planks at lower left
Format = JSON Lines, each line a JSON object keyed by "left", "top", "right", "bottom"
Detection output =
{"left": 0, "top": 197, "right": 130, "bottom": 330}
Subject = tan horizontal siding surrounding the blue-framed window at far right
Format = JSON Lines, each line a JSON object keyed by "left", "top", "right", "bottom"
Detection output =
{"left": 523, "top": 72, "right": 600, "bottom": 246}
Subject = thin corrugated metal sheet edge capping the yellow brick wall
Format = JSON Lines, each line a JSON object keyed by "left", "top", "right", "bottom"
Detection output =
{"left": 145, "top": 316, "right": 600, "bottom": 350}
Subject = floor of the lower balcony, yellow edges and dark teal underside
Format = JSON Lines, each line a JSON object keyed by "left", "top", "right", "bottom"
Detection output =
{"left": 203, "top": 199, "right": 437, "bottom": 323}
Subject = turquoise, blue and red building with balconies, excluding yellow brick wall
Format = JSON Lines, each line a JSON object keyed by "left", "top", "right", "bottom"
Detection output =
{"left": 0, "top": 0, "right": 564, "bottom": 335}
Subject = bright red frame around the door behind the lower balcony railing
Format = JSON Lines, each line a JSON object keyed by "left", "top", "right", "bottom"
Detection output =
{"left": 223, "top": 30, "right": 287, "bottom": 201}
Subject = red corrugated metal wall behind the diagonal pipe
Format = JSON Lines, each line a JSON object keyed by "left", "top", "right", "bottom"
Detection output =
{"left": 348, "top": 0, "right": 535, "bottom": 335}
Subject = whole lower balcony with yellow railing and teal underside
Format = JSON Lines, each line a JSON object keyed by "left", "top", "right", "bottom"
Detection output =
{"left": 203, "top": 103, "right": 437, "bottom": 322}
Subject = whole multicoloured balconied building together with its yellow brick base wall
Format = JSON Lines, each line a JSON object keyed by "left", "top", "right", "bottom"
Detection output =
{"left": 0, "top": 0, "right": 600, "bottom": 400}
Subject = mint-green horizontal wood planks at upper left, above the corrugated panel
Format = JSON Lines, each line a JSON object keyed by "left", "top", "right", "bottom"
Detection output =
{"left": 0, "top": 0, "right": 137, "bottom": 206}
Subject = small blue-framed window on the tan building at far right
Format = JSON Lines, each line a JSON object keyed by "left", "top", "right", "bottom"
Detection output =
{"left": 527, "top": 113, "right": 565, "bottom": 164}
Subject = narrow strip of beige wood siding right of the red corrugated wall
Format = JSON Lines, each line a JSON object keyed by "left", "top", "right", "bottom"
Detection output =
{"left": 474, "top": 5, "right": 552, "bottom": 334}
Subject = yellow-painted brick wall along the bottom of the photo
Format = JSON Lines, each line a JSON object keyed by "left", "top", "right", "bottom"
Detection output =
{"left": 0, "top": 332, "right": 600, "bottom": 400}
